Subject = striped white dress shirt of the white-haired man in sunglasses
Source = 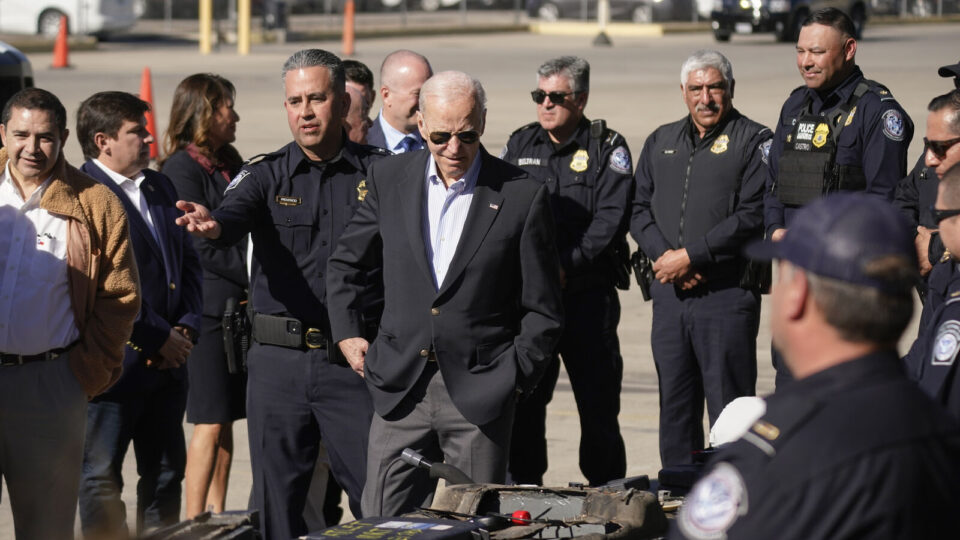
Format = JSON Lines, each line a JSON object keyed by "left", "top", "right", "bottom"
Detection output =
{"left": 423, "top": 155, "right": 480, "bottom": 290}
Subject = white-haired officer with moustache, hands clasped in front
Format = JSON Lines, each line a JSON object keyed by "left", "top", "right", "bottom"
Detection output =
{"left": 630, "top": 51, "right": 772, "bottom": 467}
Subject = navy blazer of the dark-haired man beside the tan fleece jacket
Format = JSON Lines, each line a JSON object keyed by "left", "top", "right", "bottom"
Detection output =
{"left": 80, "top": 161, "right": 203, "bottom": 395}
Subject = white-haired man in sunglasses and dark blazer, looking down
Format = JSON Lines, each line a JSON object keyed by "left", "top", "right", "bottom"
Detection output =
{"left": 327, "top": 72, "right": 562, "bottom": 516}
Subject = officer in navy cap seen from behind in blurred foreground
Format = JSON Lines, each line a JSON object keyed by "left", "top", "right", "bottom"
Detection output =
{"left": 670, "top": 193, "right": 960, "bottom": 540}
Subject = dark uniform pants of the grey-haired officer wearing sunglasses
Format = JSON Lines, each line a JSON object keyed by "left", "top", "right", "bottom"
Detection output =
{"left": 509, "top": 287, "right": 627, "bottom": 485}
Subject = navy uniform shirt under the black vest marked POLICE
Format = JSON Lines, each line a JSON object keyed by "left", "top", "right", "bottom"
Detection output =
{"left": 763, "top": 67, "right": 913, "bottom": 237}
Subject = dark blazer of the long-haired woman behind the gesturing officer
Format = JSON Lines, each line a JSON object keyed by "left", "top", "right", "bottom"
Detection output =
{"left": 160, "top": 150, "right": 249, "bottom": 317}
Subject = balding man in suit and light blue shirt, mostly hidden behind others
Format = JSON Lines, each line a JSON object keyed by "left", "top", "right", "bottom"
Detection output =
{"left": 367, "top": 49, "right": 433, "bottom": 154}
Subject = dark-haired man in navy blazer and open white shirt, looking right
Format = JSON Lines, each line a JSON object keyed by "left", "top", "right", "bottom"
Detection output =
{"left": 77, "top": 92, "right": 202, "bottom": 538}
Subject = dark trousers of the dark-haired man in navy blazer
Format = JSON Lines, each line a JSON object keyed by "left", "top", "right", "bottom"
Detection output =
{"left": 80, "top": 373, "right": 187, "bottom": 538}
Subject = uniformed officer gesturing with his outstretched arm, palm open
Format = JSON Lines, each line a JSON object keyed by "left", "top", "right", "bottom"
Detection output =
{"left": 178, "top": 49, "right": 388, "bottom": 540}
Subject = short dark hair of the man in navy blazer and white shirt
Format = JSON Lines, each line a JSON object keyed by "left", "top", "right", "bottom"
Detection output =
{"left": 77, "top": 91, "right": 150, "bottom": 159}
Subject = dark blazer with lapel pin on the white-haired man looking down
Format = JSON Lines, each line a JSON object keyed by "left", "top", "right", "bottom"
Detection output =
{"left": 327, "top": 148, "right": 563, "bottom": 425}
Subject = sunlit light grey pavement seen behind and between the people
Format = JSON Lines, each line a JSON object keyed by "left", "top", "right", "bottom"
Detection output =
{"left": 0, "top": 19, "right": 960, "bottom": 539}
